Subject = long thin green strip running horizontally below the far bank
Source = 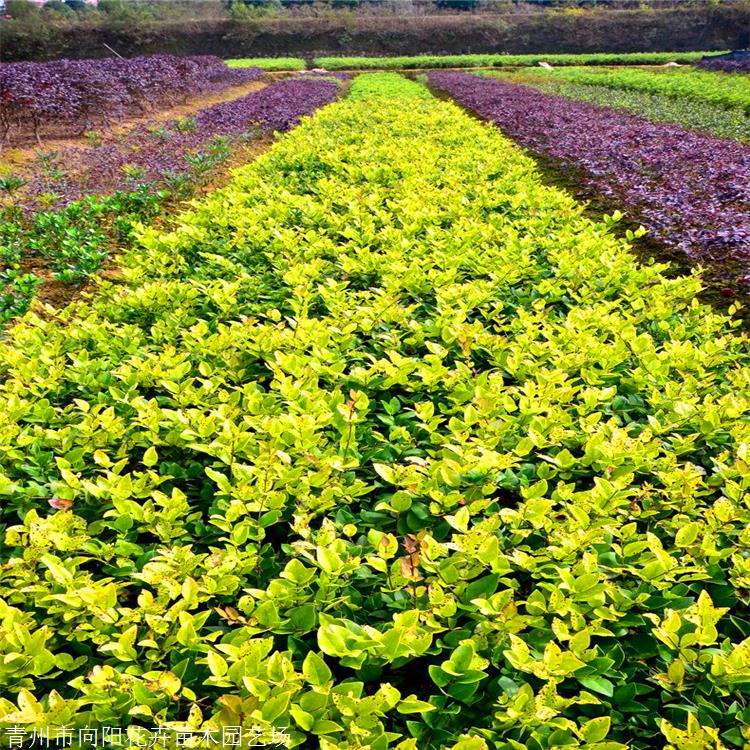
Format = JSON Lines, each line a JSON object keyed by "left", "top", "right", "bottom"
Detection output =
{"left": 316, "top": 52, "right": 724, "bottom": 70}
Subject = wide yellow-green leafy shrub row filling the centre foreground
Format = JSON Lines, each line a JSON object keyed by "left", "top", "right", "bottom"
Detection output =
{"left": 0, "top": 74, "right": 750, "bottom": 750}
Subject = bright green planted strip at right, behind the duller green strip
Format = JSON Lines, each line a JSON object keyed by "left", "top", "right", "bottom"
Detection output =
{"left": 524, "top": 68, "right": 750, "bottom": 114}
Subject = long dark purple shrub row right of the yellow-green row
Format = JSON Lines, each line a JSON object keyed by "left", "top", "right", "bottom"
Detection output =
{"left": 429, "top": 73, "right": 750, "bottom": 283}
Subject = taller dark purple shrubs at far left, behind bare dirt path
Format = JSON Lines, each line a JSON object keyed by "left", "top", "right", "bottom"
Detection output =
{"left": 0, "top": 55, "right": 262, "bottom": 140}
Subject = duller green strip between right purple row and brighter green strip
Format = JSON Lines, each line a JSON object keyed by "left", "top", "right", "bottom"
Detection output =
{"left": 481, "top": 68, "right": 750, "bottom": 141}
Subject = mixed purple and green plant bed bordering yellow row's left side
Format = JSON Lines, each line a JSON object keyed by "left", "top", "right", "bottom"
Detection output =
{"left": 0, "top": 77, "right": 343, "bottom": 322}
